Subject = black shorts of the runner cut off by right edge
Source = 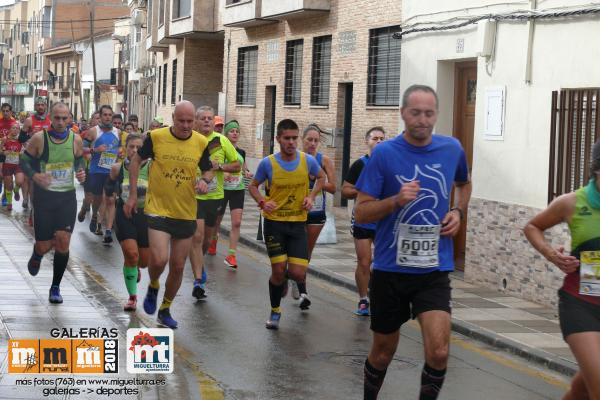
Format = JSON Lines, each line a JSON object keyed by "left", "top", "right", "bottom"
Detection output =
{"left": 558, "top": 289, "right": 600, "bottom": 340}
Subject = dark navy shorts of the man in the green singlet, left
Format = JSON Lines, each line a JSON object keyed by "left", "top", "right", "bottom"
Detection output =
{"left": 33, "top": 184, "right": 77, "bottom": 242}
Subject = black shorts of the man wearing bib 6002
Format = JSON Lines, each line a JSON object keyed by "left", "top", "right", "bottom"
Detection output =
{"left": 369, "top": 270, "right": 452, "bottom": 334}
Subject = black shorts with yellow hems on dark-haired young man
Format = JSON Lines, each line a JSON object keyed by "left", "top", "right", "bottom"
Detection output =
{"left": 263, "top": 219, "right": 308, "bottom": 267}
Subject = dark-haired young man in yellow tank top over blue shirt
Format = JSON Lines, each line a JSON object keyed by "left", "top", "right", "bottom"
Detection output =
{"left": 249, "top": 119, "right": 325, "bottom": 329}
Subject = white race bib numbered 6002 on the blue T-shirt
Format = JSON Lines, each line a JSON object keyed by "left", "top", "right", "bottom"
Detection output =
{"left": 396, "top": 224, "right": 440, "bottom": 268}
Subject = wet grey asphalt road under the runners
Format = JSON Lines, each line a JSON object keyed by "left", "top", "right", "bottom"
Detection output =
{"left": 14, "top": 189, "right": 568, "bottom": 400}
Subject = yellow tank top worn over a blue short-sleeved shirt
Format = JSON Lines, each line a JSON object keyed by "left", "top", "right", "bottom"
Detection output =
{"left": 263, "top": 152, "right": 309, "bottom": 222}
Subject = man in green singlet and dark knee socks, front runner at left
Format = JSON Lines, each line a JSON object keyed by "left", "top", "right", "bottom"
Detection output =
{"left": 20, "top": 103, "right": 85, "bottom": 303}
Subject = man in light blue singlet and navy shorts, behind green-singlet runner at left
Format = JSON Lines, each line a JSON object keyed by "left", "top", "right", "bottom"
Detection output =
{"left": 87, "top": 104, "right": 120, "bottom": 243}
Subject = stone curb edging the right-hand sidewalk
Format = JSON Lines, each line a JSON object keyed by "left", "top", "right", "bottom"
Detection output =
{"left": 220, "top": 225, "right": 579, "bottom": 376}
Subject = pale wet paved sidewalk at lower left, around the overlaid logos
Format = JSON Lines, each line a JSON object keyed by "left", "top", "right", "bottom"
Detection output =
{"left": 0, "top": 212, "right": 159, "bottom": 399}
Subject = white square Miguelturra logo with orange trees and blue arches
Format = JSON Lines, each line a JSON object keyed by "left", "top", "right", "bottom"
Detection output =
{"left": 127, "top": 328, "right": 175, "bottom": 374}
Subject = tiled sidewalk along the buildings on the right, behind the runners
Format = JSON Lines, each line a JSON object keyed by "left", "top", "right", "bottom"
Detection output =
{"left": 221, "top": 194, "right": 578, "bottom": 375}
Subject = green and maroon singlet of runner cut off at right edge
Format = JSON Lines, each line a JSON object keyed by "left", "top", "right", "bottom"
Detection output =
{"left": 562, "top": 187, "right": 600, "bottom": 304}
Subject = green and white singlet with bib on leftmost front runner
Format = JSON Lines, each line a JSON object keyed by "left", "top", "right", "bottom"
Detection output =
{"left": 40, "top": 131, "right": 75, "bottom": 192}
